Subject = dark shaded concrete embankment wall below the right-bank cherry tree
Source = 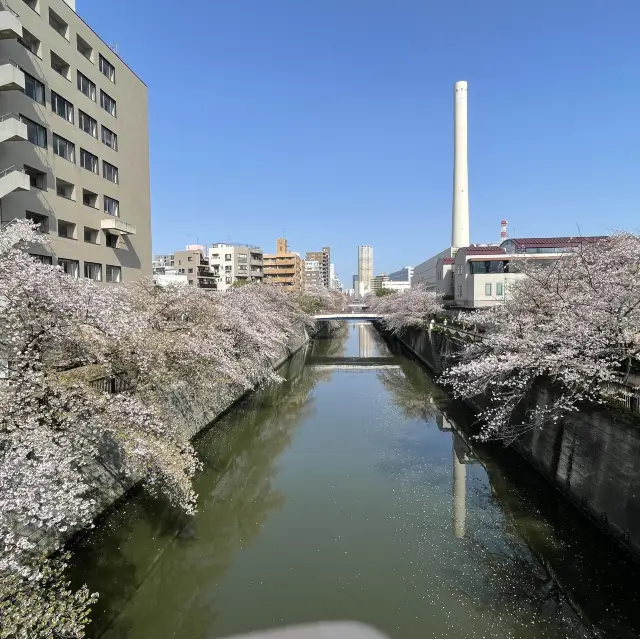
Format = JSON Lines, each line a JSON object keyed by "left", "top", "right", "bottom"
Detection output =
{"left": 384, "top": 324, "right": 640, "bottom": 560}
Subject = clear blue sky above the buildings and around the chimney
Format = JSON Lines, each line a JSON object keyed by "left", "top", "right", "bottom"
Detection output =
{"left": 77, "top": 0, "right": 640, "bottom": 285}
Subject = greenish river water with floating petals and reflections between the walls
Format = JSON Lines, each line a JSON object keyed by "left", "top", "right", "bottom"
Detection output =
{"left": 72, "top": 322, "right": 640, "bottom": 639}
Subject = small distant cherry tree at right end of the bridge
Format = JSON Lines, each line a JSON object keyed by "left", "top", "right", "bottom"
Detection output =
{"left": 368, "top": 285, "right": 442, "bottom": 333}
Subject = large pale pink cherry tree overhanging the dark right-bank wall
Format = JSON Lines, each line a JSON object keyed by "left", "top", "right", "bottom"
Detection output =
{"left": 443, "top": 233, "right": 640, "bottom": 439}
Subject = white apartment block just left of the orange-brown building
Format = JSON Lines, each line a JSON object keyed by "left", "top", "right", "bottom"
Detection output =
{"left": 209, "top": 243, "right": 264, "bottom": 291}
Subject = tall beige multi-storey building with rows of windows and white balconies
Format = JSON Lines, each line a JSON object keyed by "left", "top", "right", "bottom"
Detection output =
{"left": 0, "top": 0, "right": 152, "bottom": 282}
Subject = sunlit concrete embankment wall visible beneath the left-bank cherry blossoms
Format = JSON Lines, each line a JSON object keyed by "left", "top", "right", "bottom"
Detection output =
{"left": 29, "top": 326, "right": 310, "bottom": 553}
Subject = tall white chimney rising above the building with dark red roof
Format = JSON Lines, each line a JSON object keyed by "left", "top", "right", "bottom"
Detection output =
{"left": 451, "top": 80, "right": 469, "bottom": 248}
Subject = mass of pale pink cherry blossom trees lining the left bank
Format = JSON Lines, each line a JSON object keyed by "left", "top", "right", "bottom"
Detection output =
{"left": 0, "top": 221, "right": 311, "bottom": 638}
